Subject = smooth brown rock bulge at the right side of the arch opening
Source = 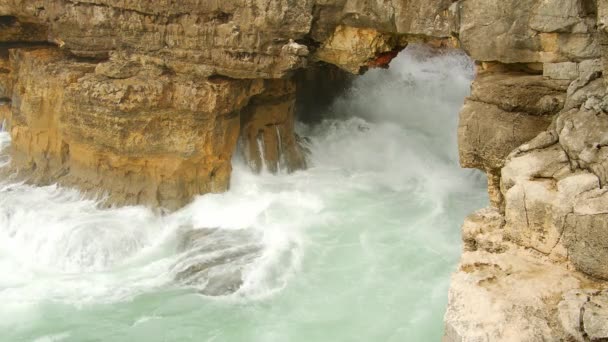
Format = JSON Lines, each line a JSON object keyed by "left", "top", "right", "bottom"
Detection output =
{"left": 458, "top": 70, "right": 569, "bottom": 207}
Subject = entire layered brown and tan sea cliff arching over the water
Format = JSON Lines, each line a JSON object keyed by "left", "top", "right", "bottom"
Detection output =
{"left": 0, "top": 0, "right": 608, "bottom": 341}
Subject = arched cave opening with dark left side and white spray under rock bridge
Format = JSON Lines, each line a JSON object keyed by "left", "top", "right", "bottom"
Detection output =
{"left": 295, "top": 44, "right": 476, "bottom": 164}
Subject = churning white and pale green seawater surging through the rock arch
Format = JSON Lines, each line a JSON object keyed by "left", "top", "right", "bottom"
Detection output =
{"left": 0, "top": 49, "right": 487, "bottom": 342}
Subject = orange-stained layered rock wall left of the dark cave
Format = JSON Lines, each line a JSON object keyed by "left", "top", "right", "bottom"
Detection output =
{"left": 4, "top": 49, "right": 264, "bottom": 209}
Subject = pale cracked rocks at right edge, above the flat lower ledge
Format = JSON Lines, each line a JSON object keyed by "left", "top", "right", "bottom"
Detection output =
{"left": 502, "top": 72, "right": 608, "bottom": 279}
